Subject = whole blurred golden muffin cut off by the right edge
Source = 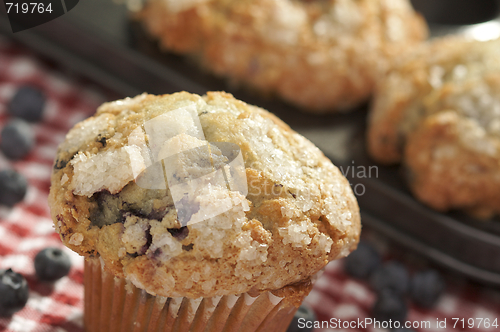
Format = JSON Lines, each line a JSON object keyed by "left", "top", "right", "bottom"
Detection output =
{"left": 367, "top": 37, "right": 500, "bottom": 218}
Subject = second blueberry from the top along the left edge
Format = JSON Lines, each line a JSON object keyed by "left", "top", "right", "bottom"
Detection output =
{"left": 0, "top": 119, "right": 35, "bottom": 159}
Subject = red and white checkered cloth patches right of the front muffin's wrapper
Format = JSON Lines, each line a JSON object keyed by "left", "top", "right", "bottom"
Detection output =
{"left": 306, "top": 261, "right": 500, "bottom": 332}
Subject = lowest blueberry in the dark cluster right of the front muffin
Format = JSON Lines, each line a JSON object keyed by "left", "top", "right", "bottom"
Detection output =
{"left": 372, "top": 289, "right": 408, "bottom": 322}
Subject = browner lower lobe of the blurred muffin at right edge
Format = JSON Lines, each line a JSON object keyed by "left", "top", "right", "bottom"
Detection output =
{"left": 405, "top": 111, "right": 500, "bottom": 218}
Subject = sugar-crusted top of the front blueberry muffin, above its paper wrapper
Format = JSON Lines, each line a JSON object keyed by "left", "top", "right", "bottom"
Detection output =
{"left": 49, "top": 92, "right": 360, "bottom": 298}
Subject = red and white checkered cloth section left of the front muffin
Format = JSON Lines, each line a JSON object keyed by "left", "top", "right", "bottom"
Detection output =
{"left": 0, "top": 39, "right": 105, "bottom": 332}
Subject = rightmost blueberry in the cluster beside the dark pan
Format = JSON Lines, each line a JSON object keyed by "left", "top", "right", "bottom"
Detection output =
{"left": 411, "top": 270, "right": 445, "bottom": 308}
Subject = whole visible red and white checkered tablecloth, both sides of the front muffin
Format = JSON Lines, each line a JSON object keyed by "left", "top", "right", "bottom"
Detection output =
{"left": 0, "top": 37, "right": 500, "bottom": 332}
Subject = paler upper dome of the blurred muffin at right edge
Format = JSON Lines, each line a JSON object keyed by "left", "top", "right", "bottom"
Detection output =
{"left": 368, "top": 36, "right": 500, "bottom": 163}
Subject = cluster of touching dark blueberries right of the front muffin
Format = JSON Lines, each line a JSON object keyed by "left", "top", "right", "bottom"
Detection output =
{"left": 344, "top": 241, "right": 445, "bottom": 331}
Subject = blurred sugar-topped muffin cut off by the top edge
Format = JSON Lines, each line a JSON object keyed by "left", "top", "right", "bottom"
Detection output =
{"left": 138, "top": 0, "right": 427, "bottom": 113}
